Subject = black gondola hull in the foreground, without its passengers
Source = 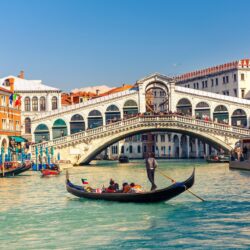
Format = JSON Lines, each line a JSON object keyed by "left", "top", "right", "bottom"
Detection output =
{"left": 66, "top": 170, "right": 195, "bottom": 202}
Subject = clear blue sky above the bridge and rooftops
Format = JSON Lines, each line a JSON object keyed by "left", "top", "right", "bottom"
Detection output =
{"left": 0, "top": 0, "right": 250, "bottom": 90}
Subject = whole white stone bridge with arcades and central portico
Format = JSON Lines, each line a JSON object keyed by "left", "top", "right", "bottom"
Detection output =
{"left": 31, "top": 74, "right": 250, "bottom": 164}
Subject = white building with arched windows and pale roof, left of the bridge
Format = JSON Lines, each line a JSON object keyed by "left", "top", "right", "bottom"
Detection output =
{"left": 0, "top": 71, "right": 61, "bottom": 140}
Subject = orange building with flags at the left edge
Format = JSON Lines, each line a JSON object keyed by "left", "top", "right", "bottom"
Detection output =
{"left": 0, "top": 79, "right": 21, "bottom": 153}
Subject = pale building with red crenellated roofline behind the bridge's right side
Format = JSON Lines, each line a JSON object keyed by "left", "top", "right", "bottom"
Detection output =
{"left": 175, "top": 59, "right": 250, "bottom": 99}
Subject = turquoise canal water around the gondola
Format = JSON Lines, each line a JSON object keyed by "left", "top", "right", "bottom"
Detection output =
{"left": 0, "top": 161, "right": 250, "bottom": 250}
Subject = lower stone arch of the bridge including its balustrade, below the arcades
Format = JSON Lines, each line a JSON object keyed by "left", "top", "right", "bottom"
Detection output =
{"left": 32, "top": 114, "right": 250, "bottom": 165}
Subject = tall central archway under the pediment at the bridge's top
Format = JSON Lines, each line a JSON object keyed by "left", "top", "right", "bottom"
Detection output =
{"left": 146, "top": 82, "right": 169, "bottom": 113}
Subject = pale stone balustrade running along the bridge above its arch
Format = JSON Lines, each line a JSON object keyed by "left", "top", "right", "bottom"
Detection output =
{"left": 32, "top": 114, "right": 250, "bottom": 151}
